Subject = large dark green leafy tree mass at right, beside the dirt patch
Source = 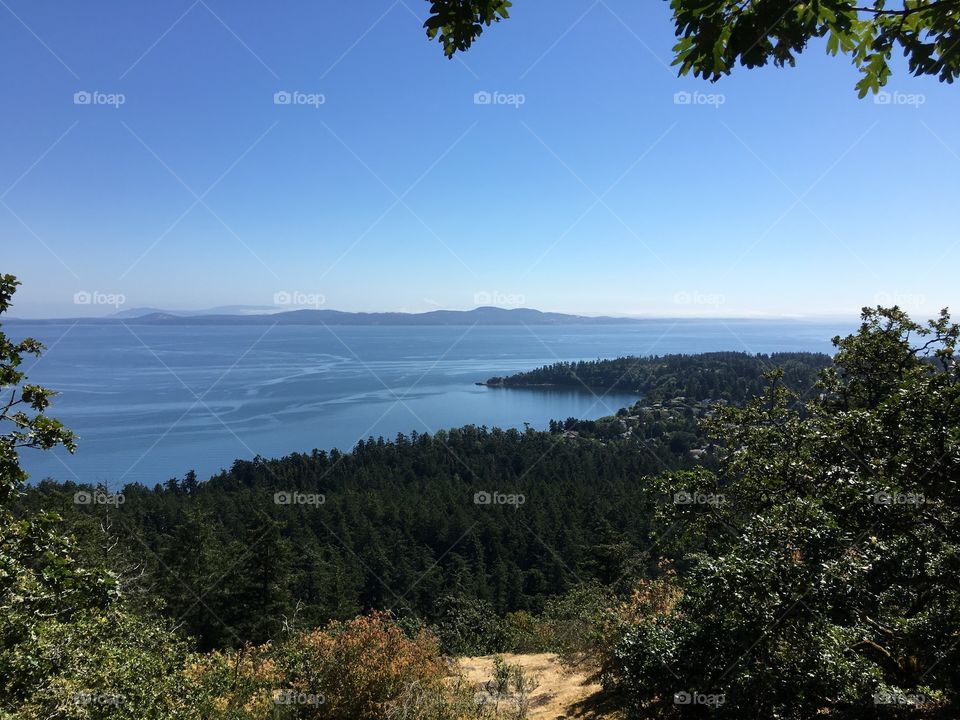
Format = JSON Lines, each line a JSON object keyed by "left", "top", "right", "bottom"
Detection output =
{"left": 608, "top": 308, "right": 960, "bottom": 720}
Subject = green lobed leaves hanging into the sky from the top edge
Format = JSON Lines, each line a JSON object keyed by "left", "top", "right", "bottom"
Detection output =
{"left": 424, "top": 0, "right": 960, "bottom": 97}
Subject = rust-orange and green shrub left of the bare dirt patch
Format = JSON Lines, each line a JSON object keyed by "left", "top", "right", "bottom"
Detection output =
{"left": 191, "top": 612, "right": 465, "bottom": 720}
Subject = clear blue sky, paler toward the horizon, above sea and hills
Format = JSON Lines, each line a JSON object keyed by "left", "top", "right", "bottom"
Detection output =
{"left": 0, "top": 0, "right": 960, "bottom": 317}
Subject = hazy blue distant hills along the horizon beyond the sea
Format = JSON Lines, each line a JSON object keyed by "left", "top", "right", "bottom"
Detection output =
{"left": 11, "top": 306, "right": 643, "bottom": 325}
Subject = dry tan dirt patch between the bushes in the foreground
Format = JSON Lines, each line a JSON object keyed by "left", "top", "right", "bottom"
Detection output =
{"left": 458, "top": 653, "right": 613, "bottom": 720}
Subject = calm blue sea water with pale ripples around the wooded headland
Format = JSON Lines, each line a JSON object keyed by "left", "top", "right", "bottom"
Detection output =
{"left": 11, "top": 320, "right": 852, "bottom": 488}
